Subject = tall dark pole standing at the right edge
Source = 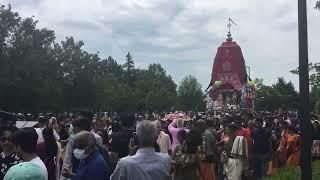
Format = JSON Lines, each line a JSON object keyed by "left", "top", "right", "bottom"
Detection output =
{"left": 298, "top": 0, "right": 312, "bottom": 180}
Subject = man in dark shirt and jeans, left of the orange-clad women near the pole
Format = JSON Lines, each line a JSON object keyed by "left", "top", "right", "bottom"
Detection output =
{"left": 251, "top": 121, "right": 272, "bottom": 178}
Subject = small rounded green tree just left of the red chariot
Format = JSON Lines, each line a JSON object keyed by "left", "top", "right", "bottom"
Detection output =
{"left": 177, "top": 75, "right": 205, "bottom": 110}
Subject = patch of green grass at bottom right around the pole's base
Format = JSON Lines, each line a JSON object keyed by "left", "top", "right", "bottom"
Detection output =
{"left": 267, "top": 161, "right": 320, "bottom": 180}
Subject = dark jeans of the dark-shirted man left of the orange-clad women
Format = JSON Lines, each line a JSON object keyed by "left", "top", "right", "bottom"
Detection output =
{"left": 253, "top": 154, "right": 268, "bottom": 179}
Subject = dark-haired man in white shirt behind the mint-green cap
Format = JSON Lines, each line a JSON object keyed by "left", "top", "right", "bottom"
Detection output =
{"left": 13, "top": 128, "right": 48, "bottom": 179}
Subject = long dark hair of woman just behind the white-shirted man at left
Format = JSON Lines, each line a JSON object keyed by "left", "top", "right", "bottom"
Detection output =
{"left": 42, "top": 127, "right": 58, "bottom": 158}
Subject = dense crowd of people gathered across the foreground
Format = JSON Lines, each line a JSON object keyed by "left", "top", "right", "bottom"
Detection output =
{"left": 0, "top": 109, "right": 320, "bottom": 180}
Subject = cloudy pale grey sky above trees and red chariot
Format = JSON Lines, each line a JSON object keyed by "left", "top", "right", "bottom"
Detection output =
{"left": 0, "top": 0, "right": 320, "bottom": 88}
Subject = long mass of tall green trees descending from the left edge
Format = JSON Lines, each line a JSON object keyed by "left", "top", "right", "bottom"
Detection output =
{"left": 0, "top": 6, "right": 177, "bottom": 112}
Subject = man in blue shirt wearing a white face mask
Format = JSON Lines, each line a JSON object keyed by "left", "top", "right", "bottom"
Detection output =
{"left": 62, "top": 131, "right": 109, "bottom": 180}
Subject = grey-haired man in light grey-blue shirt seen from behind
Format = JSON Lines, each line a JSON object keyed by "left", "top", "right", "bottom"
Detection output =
{"left": 110, "top": 121, "right": 171, "bottom": 180}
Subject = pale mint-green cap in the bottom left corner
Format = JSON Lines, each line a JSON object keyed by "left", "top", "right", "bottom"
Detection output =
{"left": 4, "top": 162, "right": 47, "bottom": 180}
